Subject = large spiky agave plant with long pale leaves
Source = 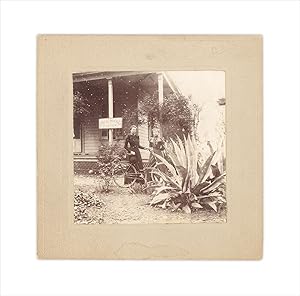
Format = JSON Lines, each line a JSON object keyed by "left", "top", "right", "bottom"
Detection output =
{"left": 150, "top": 135, "right": 226, "bottom": 213}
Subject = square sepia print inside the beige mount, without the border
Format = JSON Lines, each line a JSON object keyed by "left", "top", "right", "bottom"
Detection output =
{"left": 73, "top": 71, "right": 227, "bottom": 224}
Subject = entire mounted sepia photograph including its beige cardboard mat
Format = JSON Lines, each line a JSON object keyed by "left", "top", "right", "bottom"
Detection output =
{"left": 37, "top": 35, "right": 262, "bottom": 260}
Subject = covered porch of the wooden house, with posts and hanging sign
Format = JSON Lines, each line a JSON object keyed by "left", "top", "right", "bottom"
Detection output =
{"left": 73, "top": 71, "right": 180, "bottom": 170}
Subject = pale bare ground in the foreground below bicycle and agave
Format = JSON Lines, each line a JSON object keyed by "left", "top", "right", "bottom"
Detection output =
{"left": 74, "top": 176, "right": 226, "bottom": 224}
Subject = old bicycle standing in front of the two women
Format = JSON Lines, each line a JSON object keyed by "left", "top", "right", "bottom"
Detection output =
{"left": 112, "top": 151, "right": 163, "bottom": 188}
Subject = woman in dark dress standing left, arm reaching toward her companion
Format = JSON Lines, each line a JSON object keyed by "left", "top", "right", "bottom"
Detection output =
{"left": 124, "top": 125, "right": 149, "bottom": 171}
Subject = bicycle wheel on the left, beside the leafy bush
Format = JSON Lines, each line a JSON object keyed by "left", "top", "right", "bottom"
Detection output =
{"left": 113, "top": 162, "right": 138, "bottom": 188}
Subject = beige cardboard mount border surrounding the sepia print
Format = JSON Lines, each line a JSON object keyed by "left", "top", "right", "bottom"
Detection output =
{"left": 37, "top": 35, "right": 263, "bottom": 260}
